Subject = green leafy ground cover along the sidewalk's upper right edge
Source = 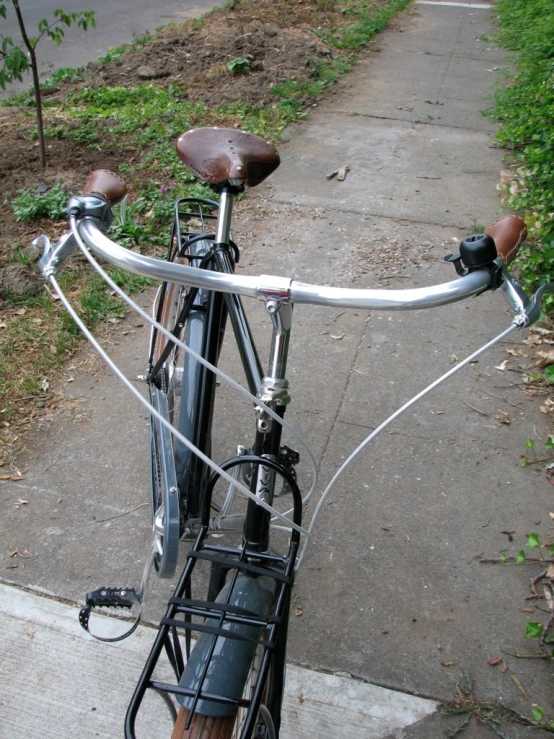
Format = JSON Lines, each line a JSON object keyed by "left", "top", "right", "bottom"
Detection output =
{"left": 491, "top": 0, "right": 554, "bottom": 310}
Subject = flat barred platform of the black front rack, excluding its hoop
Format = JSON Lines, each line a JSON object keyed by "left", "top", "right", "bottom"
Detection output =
{"left": 125, "top": 527, "right": 299, "bottom": 739}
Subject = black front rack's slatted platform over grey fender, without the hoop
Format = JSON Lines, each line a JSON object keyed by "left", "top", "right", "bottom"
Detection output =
{"left": 125, "top": 527, "right": 298, "bottom": 739}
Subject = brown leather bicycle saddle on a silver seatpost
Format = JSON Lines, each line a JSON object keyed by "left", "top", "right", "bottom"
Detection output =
{"left": 176, "top": 127, "right": 281, "bottom": 187}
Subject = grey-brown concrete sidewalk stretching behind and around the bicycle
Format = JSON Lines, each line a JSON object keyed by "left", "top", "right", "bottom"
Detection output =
{"left": 0, "top": 2, "right": 554, "bottom": 739}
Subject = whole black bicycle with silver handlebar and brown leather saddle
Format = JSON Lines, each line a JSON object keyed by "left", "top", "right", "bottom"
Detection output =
{"left": 35, "top": 128, "right": 554, "bottom": 739}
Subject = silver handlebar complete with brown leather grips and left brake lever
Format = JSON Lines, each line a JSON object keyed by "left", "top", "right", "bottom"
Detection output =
{"left": 36, "top": 170, "right": 527, "bottom": 318}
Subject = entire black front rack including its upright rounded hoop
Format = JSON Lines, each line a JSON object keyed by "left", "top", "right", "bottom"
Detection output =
{"left": 125, "top": 455, "right": 302, "bottom": 739}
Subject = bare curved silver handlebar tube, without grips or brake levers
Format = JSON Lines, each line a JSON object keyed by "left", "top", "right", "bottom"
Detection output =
{"left": 71, "top": 219, "right": 490, "bottom": 310}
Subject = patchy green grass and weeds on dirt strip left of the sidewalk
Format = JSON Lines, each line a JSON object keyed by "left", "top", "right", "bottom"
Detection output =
{"left": 0, "top": 0, "right": 409, "bottom": 450}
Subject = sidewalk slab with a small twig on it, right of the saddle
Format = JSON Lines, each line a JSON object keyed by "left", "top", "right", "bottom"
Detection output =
{"left": 273, "top": 113, "right": 501, "bottom": 228}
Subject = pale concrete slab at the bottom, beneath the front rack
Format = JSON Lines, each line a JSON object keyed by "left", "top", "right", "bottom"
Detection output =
{"left": 0, "top": 585, "right": 436, "bottom": 739}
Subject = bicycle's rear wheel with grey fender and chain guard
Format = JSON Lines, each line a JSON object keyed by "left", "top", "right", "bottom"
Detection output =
{"left": 149, "top": 227, "right": 226, "bottom": 577}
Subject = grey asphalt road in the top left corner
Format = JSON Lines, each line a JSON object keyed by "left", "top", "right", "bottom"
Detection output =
{"left": 0, "top": 0, "right": 218, "bottom": 93}
